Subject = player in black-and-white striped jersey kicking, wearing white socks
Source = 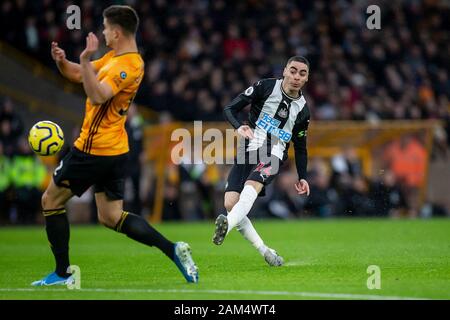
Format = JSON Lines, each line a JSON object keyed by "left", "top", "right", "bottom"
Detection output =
{"left": 213, "top": 56, "right": 310, "bottom": 266}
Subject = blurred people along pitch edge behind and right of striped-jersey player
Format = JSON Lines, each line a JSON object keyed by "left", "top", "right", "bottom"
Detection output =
{"left": 164, "top": 135, "right": 449, "bottom": 220}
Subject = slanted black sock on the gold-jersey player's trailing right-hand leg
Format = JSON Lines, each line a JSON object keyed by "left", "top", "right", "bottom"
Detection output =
{"left": 114, "top": 211, "right": 174, "bottom": 260}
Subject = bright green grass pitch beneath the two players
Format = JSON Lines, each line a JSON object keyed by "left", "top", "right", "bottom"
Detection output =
{"left": 0, "top": 219, "right": 450, "bottom": 300}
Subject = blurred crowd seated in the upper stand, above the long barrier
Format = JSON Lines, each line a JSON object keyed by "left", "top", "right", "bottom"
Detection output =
{"left": 0, "top": 0, "right": 450, "bottom": 121}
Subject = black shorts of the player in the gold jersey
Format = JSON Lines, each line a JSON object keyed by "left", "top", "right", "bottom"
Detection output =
{"left": 53, "top": 148, "right": 128, "bottom": 200}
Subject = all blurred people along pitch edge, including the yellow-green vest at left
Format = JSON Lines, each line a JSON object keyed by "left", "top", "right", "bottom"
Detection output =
{"left": 0, "top": 98, "right": 449, "bottom": 224}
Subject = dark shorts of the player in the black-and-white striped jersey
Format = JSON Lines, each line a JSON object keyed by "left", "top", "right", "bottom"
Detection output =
{"left": 225, "top": 152, "right": 283, "bottom": 197}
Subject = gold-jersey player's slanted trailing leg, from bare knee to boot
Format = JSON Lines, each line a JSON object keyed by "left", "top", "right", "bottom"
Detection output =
{"left": 95, "top": 192, "right": 198, "bottom": 282}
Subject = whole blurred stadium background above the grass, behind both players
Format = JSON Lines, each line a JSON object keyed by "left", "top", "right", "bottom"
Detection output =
{"left": 0, "top": 0, "right": 450, "bottom": 224}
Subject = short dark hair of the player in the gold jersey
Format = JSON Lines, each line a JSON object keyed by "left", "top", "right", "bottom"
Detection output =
{"left": 103, "top": 5, "right": 139, "bottom": 35}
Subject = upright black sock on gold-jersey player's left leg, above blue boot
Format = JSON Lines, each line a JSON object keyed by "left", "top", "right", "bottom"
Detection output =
{"left": 42, "top": 208, "right": 70, "bottom": 277}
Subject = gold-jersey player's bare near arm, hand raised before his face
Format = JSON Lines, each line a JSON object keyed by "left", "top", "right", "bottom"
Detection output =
{"left": 80, "top": 32, "right": 114, "bottom": 105}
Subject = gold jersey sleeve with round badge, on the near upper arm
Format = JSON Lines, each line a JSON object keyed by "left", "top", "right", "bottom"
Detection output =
{"left": 102, "top": 61, "right": 142, "bottom": 95}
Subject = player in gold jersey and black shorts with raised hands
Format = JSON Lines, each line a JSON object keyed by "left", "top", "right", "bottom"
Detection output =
{"left": 32, "top": 5, "right": 198, "bottom": 286}
